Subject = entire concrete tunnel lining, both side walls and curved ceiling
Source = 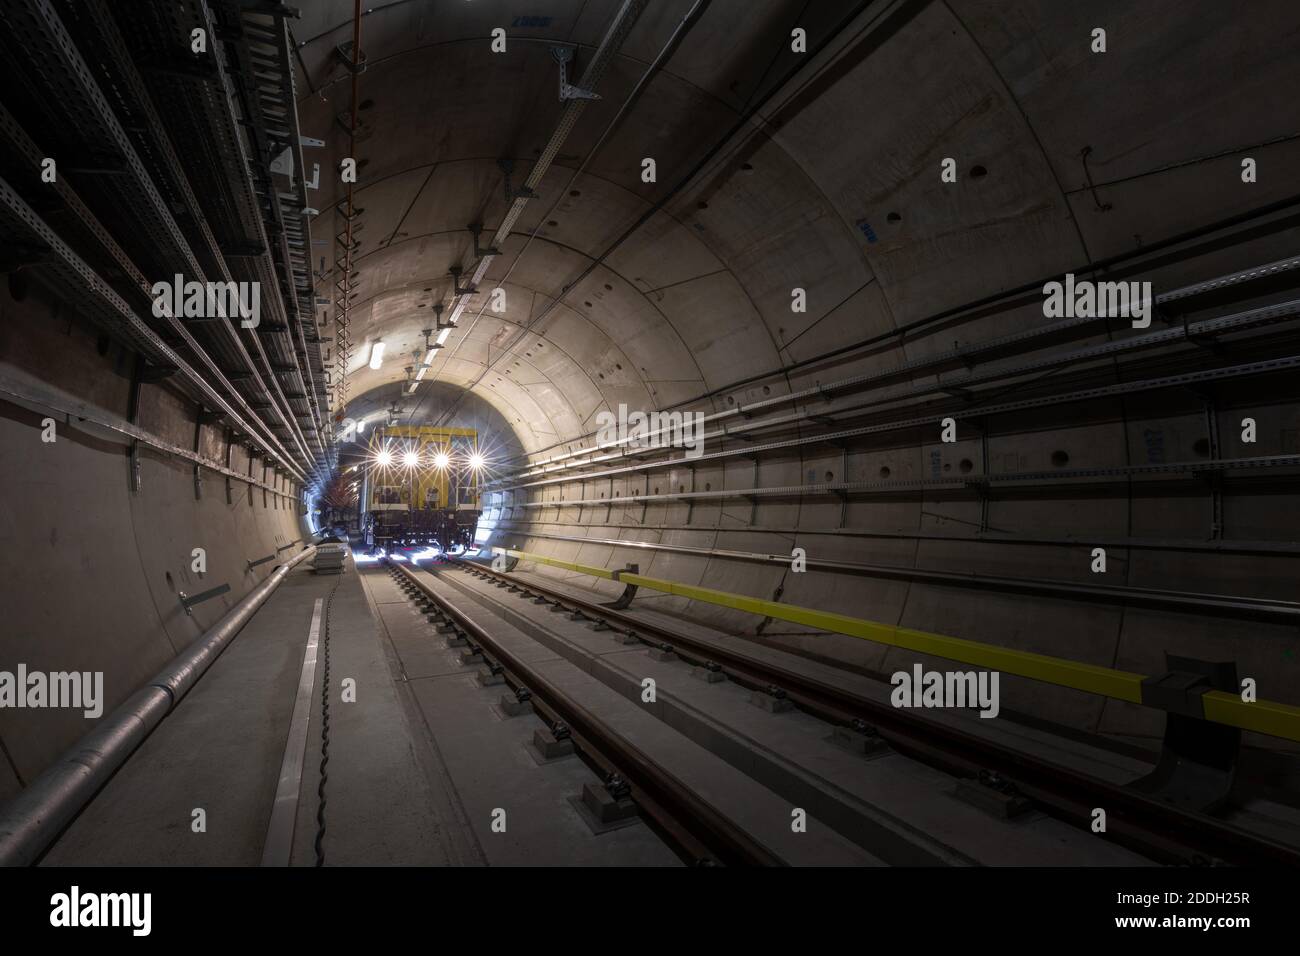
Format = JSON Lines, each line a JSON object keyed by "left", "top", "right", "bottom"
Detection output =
{"left": 0, "top": 0, "right": 1300, "bottom": 799}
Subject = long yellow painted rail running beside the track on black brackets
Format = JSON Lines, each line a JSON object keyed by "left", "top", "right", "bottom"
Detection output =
{"left": 493, "top": 548, "right": 1300, "bottom": 741}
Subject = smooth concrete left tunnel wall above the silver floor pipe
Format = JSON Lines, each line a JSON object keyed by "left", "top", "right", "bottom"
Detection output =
{"left": 0, "top": 284, "right": 307, "bottom": 800}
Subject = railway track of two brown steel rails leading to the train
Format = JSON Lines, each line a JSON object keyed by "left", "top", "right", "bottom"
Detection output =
{"left": 389, "top": 548, "right": 1300, "bottom": 866}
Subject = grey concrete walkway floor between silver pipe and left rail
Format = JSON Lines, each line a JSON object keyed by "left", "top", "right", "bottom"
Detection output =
{"left": 43, "top": 564, "right": 451, "bottom": 866}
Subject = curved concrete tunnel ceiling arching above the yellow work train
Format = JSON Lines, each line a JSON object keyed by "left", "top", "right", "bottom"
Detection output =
{"left": 293, "top": 3, "right": 1295, "bottom": 460}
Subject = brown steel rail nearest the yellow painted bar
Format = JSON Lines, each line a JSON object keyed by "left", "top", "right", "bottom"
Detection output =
{"left": 447, "top": 558, "right": 1300, "bottom": 866}
